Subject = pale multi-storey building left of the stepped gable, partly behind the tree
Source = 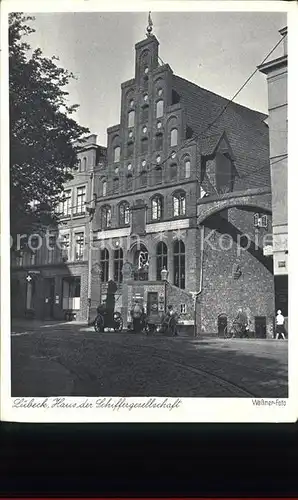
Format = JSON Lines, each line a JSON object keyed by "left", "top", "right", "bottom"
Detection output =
{"left": 11, "top": 135, "right": 105, "bottom": 321}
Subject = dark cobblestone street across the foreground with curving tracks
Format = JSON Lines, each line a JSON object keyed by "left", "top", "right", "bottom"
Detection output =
{"left": 11, "top": 324, "right": 288, "bottom": 398}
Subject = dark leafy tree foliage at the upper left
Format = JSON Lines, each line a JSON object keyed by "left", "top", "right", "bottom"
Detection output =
{"left": 9, "top": 13, "right": 88, "bottom": 242}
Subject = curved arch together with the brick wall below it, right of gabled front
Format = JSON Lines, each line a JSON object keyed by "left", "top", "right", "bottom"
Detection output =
{"left": 197, "top": 193, "right": 274, "bottom": 336}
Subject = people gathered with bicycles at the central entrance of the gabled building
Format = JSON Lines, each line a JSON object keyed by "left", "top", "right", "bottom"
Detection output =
{"left": 130, "top": 299, "right": 178, "bottom": 336}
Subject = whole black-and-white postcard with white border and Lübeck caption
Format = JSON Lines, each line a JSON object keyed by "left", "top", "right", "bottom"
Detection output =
{"left": 1, "top": 2, "right": 295, "bottom": 420}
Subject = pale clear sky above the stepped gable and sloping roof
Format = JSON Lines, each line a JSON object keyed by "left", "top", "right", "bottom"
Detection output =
{"left": 28, "top": 11, "right": 287, "bottom": 146}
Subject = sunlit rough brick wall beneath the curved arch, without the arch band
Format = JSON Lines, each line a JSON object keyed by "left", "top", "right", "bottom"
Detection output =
{"left": 199, "top": 203, "right": 274, "bottom": 336}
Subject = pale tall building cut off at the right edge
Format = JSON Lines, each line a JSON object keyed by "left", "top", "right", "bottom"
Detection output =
{"left": 259, "top": 27, "right": 288, "bottom": 316}
